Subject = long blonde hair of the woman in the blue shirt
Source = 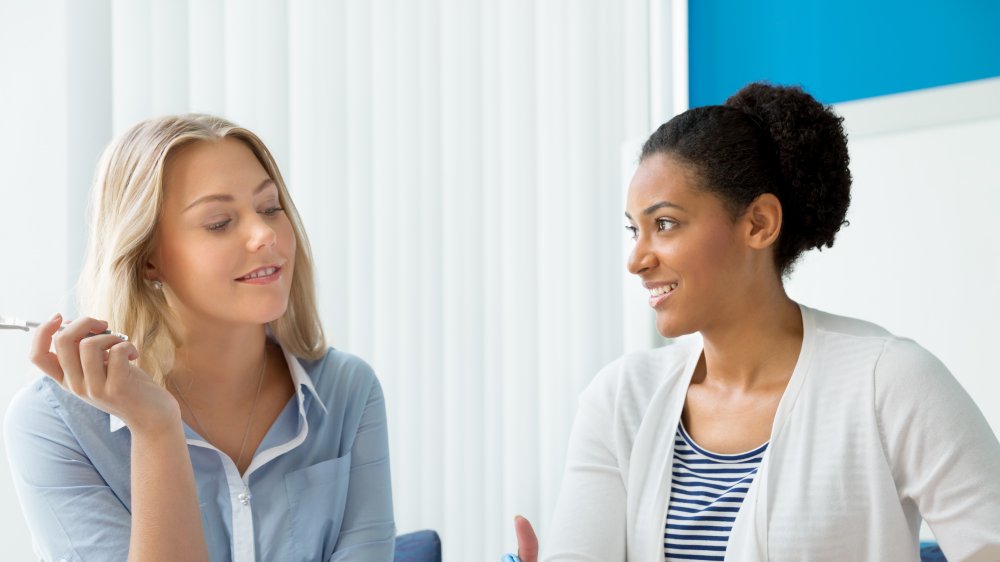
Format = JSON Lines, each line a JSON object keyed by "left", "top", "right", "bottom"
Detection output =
{"left": 77, "top": 114, "right": 326, "bottom": 384}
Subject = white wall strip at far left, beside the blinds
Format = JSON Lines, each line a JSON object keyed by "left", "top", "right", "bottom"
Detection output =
{"left": 0, "top": 1, "right": 70, "bottom": 560}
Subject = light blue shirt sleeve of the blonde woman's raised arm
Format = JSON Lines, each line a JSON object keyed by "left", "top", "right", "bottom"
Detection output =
{"left": 4, "top": 382, "right": 131, "bottom": 562}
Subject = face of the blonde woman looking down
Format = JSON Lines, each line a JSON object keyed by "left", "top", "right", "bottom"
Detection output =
{"left": 146, "top": 138, "right": 295, "bottom": 327}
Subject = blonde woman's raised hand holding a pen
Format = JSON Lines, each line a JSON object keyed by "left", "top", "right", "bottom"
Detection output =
{"left": 30, "top": 314, "right": 181, "bottom": 432}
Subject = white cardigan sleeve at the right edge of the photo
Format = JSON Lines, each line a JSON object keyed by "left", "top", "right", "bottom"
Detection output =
{"left": 875, "top": 340, "right": 1000, "bottom": 562}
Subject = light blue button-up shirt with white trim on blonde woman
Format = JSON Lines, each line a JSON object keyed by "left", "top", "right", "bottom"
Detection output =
{"left": 4, "top": 349, "right": 395, "bottom": 562}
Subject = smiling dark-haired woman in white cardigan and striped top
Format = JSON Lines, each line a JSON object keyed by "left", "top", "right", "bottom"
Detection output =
{"left": 515, "top": 84, "right": 1000, "bottom": 562}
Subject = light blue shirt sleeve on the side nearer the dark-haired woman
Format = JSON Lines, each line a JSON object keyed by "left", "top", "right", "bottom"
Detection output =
{"left": 330, "top": 366, "right": 396, "bottom": 562}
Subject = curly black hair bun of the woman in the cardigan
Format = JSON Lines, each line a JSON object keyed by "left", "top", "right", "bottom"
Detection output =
{"left": 725, "top": 82, "right": 851, "bottom": 259}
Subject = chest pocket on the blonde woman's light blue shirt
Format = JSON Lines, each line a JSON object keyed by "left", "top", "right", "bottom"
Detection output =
{"left": 285, "top": 453, "right": 351, "bottom": 562}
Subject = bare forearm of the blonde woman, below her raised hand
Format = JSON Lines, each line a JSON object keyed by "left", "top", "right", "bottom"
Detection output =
{"left": 128, "top": 420, "right": 208, "bottom": 562}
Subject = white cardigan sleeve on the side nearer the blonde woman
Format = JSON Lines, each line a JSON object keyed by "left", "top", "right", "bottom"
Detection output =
{"left": 540, "top": 369, "right": 626, "bottom": 562}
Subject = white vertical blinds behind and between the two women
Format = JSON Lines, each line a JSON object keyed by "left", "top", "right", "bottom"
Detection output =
{"left": 0, "top": 0, "right": 686, "bottom": 560}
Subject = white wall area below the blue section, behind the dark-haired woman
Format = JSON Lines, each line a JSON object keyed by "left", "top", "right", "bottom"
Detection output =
{"left": 787, "top": 79, "right": 1000, "bottom": 433}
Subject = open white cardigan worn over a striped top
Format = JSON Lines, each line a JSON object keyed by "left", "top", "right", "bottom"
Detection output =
{"left": 541, "top": 306, "right": 1000, "bottom": 562}
